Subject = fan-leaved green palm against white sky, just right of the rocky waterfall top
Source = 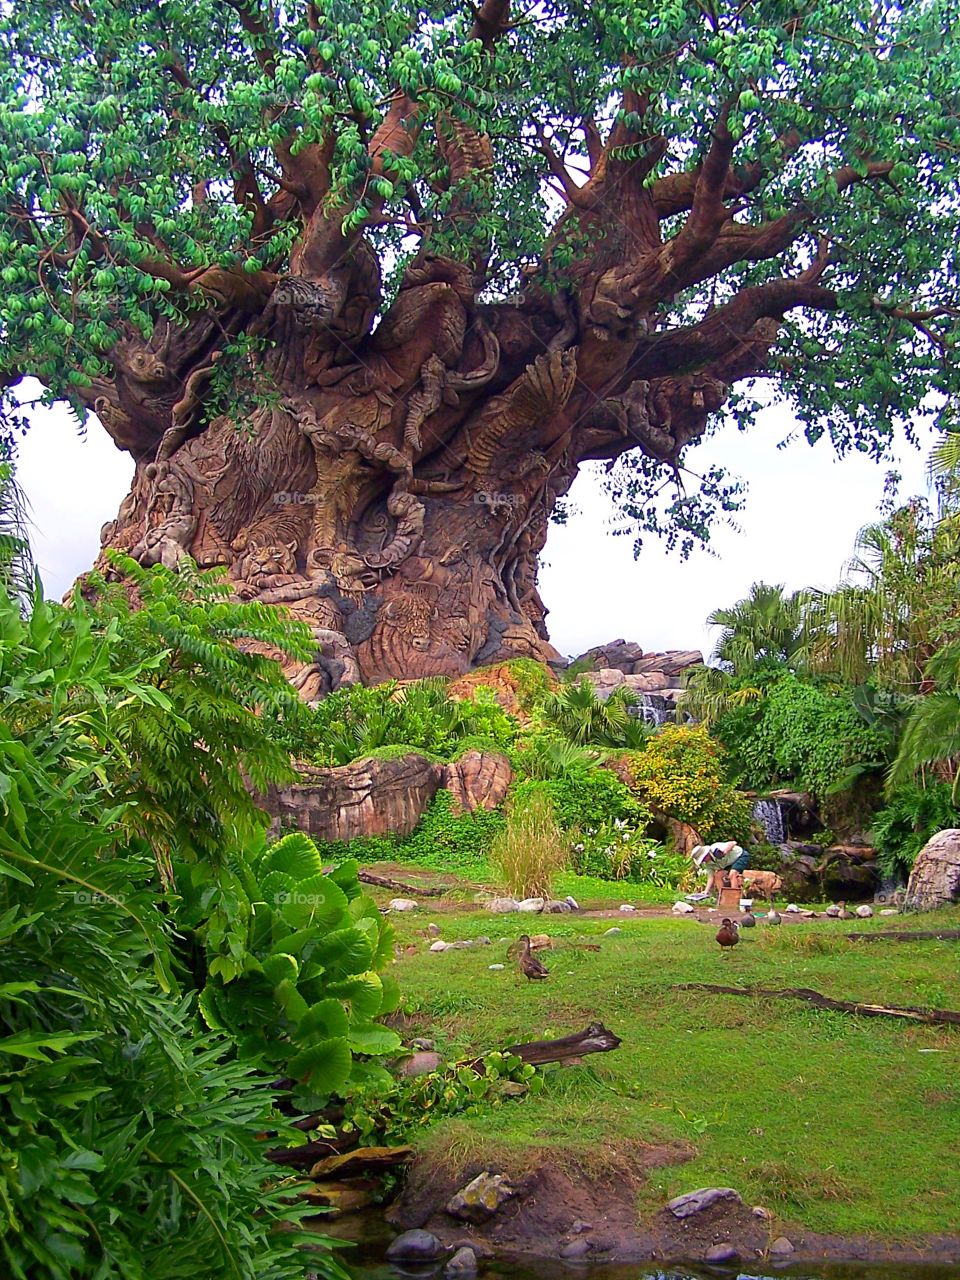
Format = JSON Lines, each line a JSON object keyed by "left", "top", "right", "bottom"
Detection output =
{"left": 707, "top": 582, "right": 806, "bottom": 676}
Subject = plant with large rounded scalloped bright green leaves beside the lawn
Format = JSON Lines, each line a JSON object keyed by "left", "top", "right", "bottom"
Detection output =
{"left": 179, "top": 832, "right": 401, "bottom": 1107}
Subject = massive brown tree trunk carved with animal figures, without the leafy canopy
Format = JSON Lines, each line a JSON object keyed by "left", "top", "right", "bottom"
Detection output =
{"left": 91, "top": 245, "right": 727, "bottom": 699}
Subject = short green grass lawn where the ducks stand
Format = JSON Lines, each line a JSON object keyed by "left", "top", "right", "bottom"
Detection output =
{"left": 386, "top": 901, "right": 960, "bottom": 1239}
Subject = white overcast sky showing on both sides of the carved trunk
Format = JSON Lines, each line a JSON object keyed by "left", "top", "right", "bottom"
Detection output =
{"left": 18, "top": 391, "right": 925, "bottom": 655}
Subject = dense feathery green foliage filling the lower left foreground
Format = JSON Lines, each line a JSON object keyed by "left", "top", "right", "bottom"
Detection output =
{"left": 0, "top": 583, "right": 325, "bottom": 1280}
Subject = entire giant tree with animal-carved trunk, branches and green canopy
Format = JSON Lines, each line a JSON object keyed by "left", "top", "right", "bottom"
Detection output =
{"left": 0, "top": 0, "right": 960, "bottom": 694}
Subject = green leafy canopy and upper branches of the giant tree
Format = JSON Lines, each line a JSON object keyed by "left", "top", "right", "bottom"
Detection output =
{"left": 0, "top": 0, "right": 960, "bottom": 542}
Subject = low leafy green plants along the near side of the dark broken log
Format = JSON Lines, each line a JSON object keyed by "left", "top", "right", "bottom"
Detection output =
{"left": 344, "top": 1051, "right": 543, "bottom": 1144}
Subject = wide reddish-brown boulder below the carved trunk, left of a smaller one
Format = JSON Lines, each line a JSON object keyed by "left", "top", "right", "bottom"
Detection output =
{"left": 259, "top": 751, "right": 444, "bottom": 842}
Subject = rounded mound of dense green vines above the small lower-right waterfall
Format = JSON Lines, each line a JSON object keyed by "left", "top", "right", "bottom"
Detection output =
{"left": 716, "top": 672, "right": 893, "bottom": 797}
